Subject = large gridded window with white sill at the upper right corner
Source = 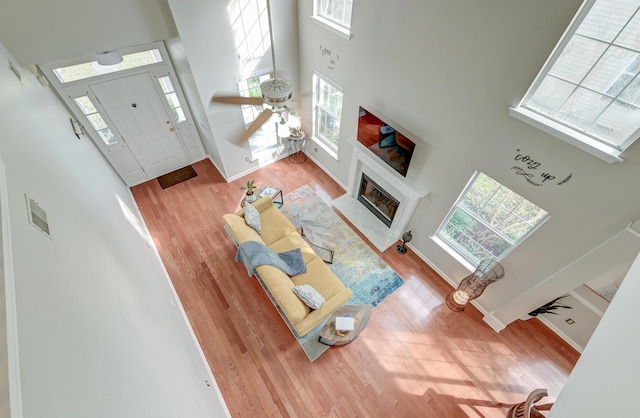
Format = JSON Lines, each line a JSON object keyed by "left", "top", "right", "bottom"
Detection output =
{"left": 511, "top": 0, "right": 640, "bottom": 162}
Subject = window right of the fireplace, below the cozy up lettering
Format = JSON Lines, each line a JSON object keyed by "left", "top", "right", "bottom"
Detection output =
{"left": 435, "top": 171, "right": 549, "bottom": 266}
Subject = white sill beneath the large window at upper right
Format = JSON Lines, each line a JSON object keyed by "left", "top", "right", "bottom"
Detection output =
{"left": 509, "top": 107, "right": 623, "bottom": 163}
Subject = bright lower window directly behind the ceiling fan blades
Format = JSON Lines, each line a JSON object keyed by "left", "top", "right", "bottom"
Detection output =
{"left": 237, "top": 69, "right": 281, "bottom": 159}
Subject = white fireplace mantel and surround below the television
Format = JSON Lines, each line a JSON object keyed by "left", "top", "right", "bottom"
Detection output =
{"left": 333, "top": 144, "right": 429, "bottom": 251}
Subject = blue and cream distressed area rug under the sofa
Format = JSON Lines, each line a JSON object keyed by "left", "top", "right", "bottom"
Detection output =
{"left": 281, "top": 185, "right": 404, "bottom": 361}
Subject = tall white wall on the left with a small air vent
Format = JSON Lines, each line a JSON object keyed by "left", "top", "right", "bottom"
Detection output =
{"left": 0, "top": 44, "right": 227, "bottom": 418}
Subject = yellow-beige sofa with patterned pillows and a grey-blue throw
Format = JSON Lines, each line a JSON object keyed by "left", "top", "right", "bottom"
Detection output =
{"left": 223, "top": 196, "right": 352, "bottom": 337}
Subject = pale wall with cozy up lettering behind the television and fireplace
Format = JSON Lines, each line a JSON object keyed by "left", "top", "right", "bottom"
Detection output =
{"left": 298, "top": 0, "right": 640, "bottom": 324}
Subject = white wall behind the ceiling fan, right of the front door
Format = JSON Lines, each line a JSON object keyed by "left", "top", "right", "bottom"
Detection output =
{"left": 169, "top": 0, "right": 298, "bottom": 179}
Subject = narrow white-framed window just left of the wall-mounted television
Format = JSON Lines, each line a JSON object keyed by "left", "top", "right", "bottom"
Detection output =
{"left": 313, "top": 72, "right": 343, "bottom": 157}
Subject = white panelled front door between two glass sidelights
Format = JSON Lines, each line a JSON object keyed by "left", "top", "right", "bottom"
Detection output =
{"left": 90, "top": 73, "right": 190, "bottom": 178}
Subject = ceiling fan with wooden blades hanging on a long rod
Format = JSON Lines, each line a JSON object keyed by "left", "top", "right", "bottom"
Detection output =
{"left": 211, "top": 0, "right": 293, "bottom": 142}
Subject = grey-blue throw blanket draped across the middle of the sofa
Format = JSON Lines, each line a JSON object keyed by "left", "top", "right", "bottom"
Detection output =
{"left": 236, "top": 241, "right": 307, "bottom": 277}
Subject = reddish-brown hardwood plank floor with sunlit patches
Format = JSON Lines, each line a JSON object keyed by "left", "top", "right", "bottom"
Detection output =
{"left": 132, "top": 159, "right": 579, "bottom": 417}
